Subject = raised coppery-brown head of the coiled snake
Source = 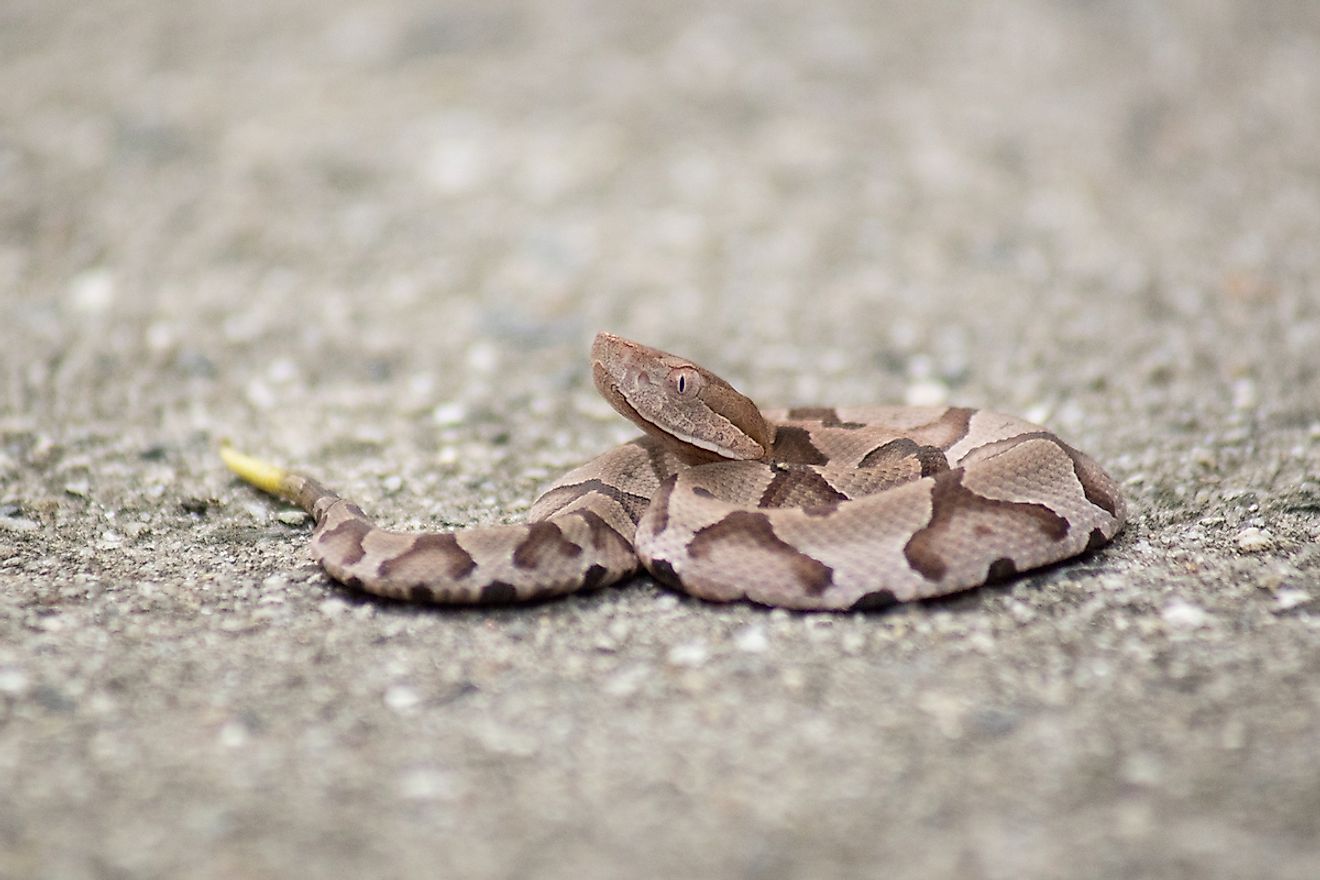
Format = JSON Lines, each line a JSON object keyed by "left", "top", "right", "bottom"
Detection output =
{"left": 591, "top": 332, "right": 772, "bottom": 462}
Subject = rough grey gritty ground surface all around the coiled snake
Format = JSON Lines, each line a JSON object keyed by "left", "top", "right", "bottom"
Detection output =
{"left": 0, "top": 0, "right": 1320, "bottom": 880}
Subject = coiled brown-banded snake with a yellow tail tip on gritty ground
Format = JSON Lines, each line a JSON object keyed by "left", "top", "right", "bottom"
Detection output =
{"left": 220, "top": 332, "right": 1126, "bottom": 611}
